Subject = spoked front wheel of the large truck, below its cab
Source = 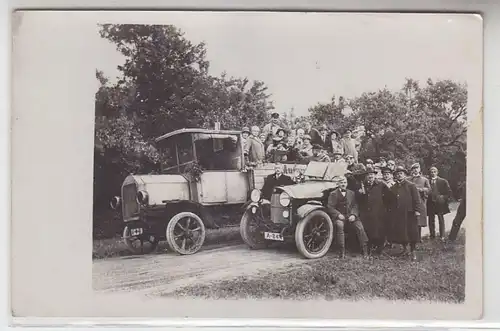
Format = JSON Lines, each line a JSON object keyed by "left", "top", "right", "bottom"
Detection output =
{"left": 166, "top": 212, "right": 205, "bottom": 255}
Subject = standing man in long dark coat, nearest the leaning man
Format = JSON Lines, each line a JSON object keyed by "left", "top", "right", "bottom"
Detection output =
{"left": 358, "top": 169, "right": 391, "bottom": 254}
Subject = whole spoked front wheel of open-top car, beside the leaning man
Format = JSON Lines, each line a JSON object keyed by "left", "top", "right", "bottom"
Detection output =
{"left": 295, "top": 210, "right": 333, "bottom": 259}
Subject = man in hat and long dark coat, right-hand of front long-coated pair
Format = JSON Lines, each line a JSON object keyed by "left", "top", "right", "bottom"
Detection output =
{"left": 387, "top": 166, "right": 421, "bottom": 260}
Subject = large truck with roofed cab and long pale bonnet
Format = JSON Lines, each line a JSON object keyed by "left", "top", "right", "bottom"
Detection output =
{"left": 111, "top": 128, "right": 306, "bottom": 255}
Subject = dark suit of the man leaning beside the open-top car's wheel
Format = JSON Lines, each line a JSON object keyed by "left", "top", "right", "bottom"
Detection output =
{"left": 327, "top": 188, "right": 368, "bottom": 249}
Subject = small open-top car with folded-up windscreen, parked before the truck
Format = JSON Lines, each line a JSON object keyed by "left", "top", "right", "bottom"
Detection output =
{"left": 240, "top": 162, "right": 347, "bottom": 259}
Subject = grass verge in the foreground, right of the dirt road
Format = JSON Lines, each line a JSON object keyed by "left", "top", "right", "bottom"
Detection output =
{"left": 173, "top": 232, "right": 465, "bottom": 303}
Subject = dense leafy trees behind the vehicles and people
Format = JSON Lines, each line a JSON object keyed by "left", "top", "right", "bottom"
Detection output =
{"left": 94, "top": 24, "right": 467, "bottom": 240}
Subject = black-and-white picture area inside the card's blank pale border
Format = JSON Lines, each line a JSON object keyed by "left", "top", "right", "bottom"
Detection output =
{"left": 89, "top": 12, "right": 481, "bottom": 314}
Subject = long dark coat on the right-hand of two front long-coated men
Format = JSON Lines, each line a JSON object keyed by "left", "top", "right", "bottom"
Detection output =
{"left": 387, "top": 179, "right": 422, "bottom": 244}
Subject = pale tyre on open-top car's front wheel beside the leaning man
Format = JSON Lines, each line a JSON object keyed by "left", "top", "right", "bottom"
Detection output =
{"left": 295, "top": 210, "right": 334, "bottom": 259}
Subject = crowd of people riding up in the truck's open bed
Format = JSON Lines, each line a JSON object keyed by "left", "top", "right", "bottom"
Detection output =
{"left": 242, "top": 113, "right": 360, "bottom": 164}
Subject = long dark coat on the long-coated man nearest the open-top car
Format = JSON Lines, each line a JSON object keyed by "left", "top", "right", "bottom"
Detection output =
{"left": 358, "top": 180, "right": 391, "bottom": 241}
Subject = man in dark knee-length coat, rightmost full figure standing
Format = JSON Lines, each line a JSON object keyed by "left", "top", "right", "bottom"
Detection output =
{"left": 427, "top": 167, "right": 451, "bottom": 240}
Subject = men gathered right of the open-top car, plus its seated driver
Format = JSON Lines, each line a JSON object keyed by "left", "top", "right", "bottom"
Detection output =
{"left": 263, "top": 160, "right": 465, "bottom": 260}
